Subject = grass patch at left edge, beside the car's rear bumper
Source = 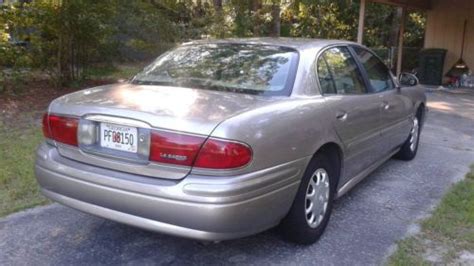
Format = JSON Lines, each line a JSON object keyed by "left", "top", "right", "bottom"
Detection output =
{"left": 0, "top": 121, "right": 48, "bottom": 217}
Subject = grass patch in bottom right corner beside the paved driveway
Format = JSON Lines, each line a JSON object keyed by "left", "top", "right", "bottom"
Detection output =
{"left": 388, "top": 165, "right": 474, "bottom": 265}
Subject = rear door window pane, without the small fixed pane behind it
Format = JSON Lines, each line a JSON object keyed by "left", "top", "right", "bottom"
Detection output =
{"left": 322, "top": 47, "right": 366, "bottom": 94}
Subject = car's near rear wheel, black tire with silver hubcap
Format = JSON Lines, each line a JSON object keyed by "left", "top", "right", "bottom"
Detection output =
{"left": 280, "top": 154, "right": 337, "bottom": 244}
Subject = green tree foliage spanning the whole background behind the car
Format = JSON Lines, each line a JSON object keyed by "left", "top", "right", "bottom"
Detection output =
{"left": 0, "top": 0, "right": 425, "bottom": 90}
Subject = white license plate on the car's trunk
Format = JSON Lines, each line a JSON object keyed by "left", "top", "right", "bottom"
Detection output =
{"left": 100, "top": 123, "right": 138, "bottom": 153}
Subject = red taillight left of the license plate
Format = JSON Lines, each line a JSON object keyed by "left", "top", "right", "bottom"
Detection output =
{"left": 43, "top": 114, "right": 79, "bottom": 146}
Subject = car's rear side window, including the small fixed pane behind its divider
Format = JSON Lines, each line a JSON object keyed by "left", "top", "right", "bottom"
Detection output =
{"left": 317, "top": 47, "right": 366, "bottom": 94}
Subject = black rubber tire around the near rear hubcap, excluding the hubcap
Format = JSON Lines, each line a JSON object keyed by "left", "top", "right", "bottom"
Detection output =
{"left": 280, "top": 154, "right": 338, "bottom": 245}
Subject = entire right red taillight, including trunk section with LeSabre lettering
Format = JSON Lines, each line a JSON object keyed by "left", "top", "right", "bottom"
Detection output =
{"left": 150, "top": 131, "right": 252, "bottom": 169}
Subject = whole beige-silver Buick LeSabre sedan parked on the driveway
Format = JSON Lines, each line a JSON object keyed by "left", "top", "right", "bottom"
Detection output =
{"left": 35, "top": 38, "right": 426, "bottom": 244}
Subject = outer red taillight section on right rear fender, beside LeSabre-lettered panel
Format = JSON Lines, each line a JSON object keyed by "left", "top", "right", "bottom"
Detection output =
{"left": 194, "top": 139, "right": 252, "bottom": 169}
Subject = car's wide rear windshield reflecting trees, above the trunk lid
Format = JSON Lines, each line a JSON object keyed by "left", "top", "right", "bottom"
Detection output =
{"left": 132, "top": 44, "right": 298, "bottom": 95}
